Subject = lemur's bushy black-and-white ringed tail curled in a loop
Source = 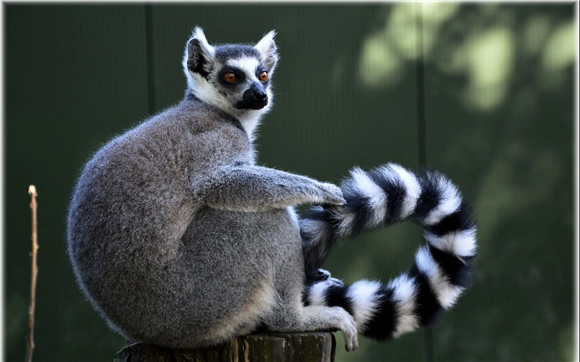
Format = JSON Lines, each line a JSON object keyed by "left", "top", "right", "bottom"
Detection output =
{"left": 301, "top": 164, "right": 476, "bottom": 340}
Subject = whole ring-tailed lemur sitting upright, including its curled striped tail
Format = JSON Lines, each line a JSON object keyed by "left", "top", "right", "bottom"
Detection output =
{"left": 67, "top": 28, "right": 476, "bottom": 351}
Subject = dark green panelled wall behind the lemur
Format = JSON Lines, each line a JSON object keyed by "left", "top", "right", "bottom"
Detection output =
{"left": 3, "top": 3, "right": 577, "bottom": 361}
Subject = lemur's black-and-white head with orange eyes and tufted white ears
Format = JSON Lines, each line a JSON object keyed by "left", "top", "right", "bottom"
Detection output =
{"left": 183, "top": 27, "right": 278, "bottom": 133}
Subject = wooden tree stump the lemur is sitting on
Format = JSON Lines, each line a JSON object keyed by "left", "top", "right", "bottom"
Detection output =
{"left": 114, "top": 332, "right": 336, "bottom": 362}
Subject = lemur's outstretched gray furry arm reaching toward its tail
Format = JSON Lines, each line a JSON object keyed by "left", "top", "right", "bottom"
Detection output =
{"left": 193, "top": 165, "right": 345, "bottom": 212}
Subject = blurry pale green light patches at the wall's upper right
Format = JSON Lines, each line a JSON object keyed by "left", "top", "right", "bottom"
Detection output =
{"left": 358, "top": 3, "right": 576, "bottom": 107}
